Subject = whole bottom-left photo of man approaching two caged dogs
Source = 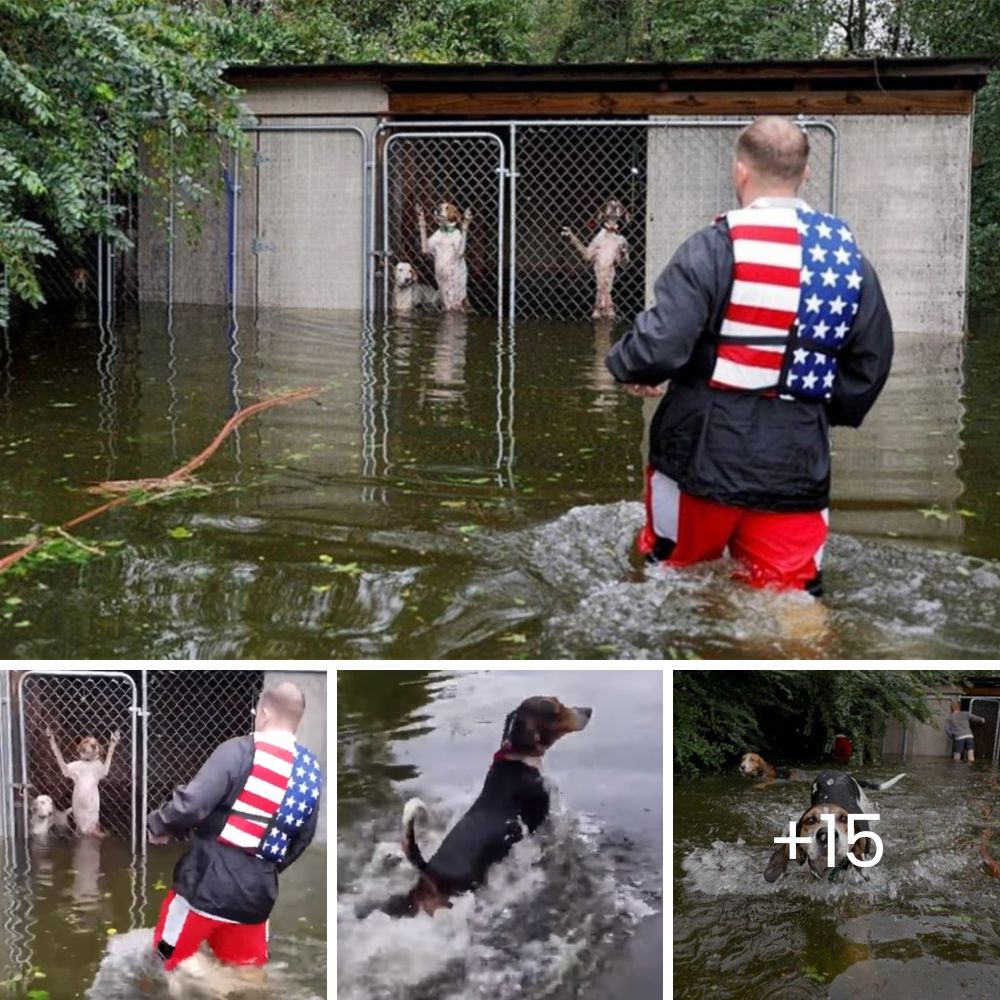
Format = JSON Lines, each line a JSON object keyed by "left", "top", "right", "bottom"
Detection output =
{"left": 0, "top": 667, "right": 328, "bottom": 1000}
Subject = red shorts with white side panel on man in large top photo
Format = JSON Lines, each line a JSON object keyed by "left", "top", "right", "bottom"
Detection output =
{"left": 636, "top": 469, "right": 827, "bottom": 596}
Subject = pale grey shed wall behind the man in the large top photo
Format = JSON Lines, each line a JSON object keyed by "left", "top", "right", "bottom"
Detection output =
{"left": 646, "top": 115, "right": 972, "bottom": 336}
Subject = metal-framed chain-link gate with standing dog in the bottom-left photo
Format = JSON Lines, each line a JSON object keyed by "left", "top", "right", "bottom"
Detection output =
{"left": 17, "top": 670, "right": 139, "bottom": 851}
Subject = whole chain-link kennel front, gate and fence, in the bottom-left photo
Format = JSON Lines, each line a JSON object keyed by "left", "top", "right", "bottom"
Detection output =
{"left": 0, "top": 670, "right": 264, "bottom": 852}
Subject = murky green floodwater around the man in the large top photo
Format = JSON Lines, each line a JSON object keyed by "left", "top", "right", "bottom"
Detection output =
{"left": 0, "top": 307, "right": 1000, "bottom": 658}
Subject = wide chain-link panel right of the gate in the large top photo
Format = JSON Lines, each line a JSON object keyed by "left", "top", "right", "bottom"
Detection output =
{"left": 512, "top": 120, "right": 836, "bottom": 319}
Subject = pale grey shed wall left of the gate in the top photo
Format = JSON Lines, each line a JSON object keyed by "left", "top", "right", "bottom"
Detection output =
{"left": 139, "top": 82, "right": 388, "bottom": 311}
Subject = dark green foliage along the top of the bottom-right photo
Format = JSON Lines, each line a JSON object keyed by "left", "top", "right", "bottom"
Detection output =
{"left": 673, "top": 670, "right": 952, "bottom": 775}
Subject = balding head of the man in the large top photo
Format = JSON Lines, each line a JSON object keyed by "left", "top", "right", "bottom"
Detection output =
{"left": 733, "top": 115, "right": 809, "bottom": 207}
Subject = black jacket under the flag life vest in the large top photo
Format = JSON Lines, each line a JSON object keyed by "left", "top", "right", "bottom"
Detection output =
{"left": 606, "top": 221, "right": 892, "bottom": 511}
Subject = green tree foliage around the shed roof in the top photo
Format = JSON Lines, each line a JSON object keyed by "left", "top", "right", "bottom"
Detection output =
{"left": 0, "top": 0, "right": 1000, "bottom": 323}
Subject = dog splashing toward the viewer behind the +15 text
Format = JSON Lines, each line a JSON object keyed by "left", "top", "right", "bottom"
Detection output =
{"left": 764, "top": 771, "right": 906, "bottom": 882}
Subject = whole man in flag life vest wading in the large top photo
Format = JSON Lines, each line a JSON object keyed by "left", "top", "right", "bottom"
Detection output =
{"left": 606, "top": 117, "right": 892, "bottom": 597}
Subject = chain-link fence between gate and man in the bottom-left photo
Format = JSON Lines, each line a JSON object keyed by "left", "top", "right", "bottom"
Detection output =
{"left": 143, "top": 670, "right": 264, "bottom": 812}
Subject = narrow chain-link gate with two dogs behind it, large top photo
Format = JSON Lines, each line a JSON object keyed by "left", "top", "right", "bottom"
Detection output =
{"left": 375, "top": 126, "right": 507, "bottom": 317}
